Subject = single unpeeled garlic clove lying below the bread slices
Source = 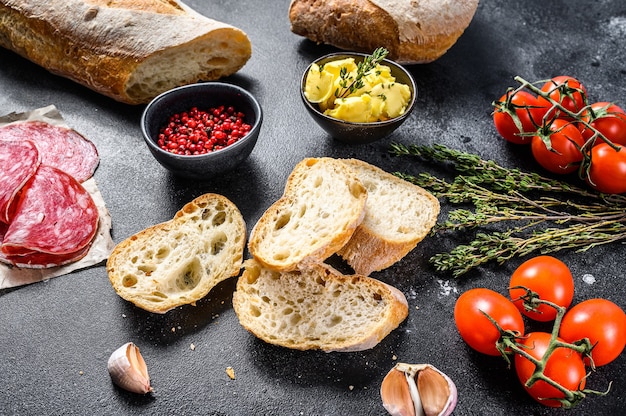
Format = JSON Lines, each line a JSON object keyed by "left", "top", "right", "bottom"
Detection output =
{"left": 108, "top": 342, "right": 153, "bottom": 394}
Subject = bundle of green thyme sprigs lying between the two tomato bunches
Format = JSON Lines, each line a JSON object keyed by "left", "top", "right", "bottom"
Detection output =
{"left": 390, "top": 144, "right": 626, "bottom": 277}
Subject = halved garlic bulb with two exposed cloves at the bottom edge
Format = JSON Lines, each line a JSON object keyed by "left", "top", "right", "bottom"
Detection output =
{"left": 380, "top": 363, "right": 457, "bottom": 416}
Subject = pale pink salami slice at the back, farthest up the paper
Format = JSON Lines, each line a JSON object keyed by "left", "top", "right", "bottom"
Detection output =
{"left": 0, "top": 121, "right": 100, "bottom": 182}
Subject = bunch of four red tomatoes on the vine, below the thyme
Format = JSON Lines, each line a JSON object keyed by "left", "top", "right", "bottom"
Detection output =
{"left": 454, "top": 256, "right": 626, "bottom": 407}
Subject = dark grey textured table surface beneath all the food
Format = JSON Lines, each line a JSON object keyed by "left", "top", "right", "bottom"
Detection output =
{"left": 0, "top": 0, "right": 626, "bottom": 415}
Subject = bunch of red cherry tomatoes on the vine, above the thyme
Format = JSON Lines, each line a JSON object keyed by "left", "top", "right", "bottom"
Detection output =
{"left": 493, "top": 75, "right": 626, "bottom": 194}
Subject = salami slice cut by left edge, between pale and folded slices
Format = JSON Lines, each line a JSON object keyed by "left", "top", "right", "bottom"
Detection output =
{"left": 0, "top": 140, "right": 41, "bottom": 224}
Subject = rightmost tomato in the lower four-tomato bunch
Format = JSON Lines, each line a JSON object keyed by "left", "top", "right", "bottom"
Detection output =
{"left": 559, "top": 299, "right": 626, "bottom": 367}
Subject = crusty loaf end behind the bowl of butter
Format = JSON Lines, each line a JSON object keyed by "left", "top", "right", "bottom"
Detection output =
{"left": 289, "top": 0, "right": 478, "bottom": 64}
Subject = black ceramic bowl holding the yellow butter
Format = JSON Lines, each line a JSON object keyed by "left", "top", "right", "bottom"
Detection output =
{"left": 300, "top": 52, "right": 417, "bottom": 144}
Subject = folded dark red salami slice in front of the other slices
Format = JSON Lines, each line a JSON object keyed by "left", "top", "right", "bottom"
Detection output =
{"left": 2, "top": 164, "right": 98, "bottom": 268}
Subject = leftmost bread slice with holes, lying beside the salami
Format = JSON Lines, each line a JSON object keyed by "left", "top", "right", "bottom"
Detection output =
{"left": 106, "top": 193, "right": 246, "bottom": 314}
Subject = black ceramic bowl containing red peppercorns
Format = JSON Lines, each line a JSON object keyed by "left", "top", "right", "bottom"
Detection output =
{"left": 141, "top": 82, "right": 263, "bottom": 179}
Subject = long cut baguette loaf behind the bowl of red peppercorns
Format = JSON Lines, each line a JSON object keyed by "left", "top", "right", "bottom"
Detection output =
{"left": 0, "top": 0, "right": 251, "bottom": 104}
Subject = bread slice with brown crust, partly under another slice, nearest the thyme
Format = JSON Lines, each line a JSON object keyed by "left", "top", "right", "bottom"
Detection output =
{"left": 337, "top": 159, "right": 440, "bottom": 276}
